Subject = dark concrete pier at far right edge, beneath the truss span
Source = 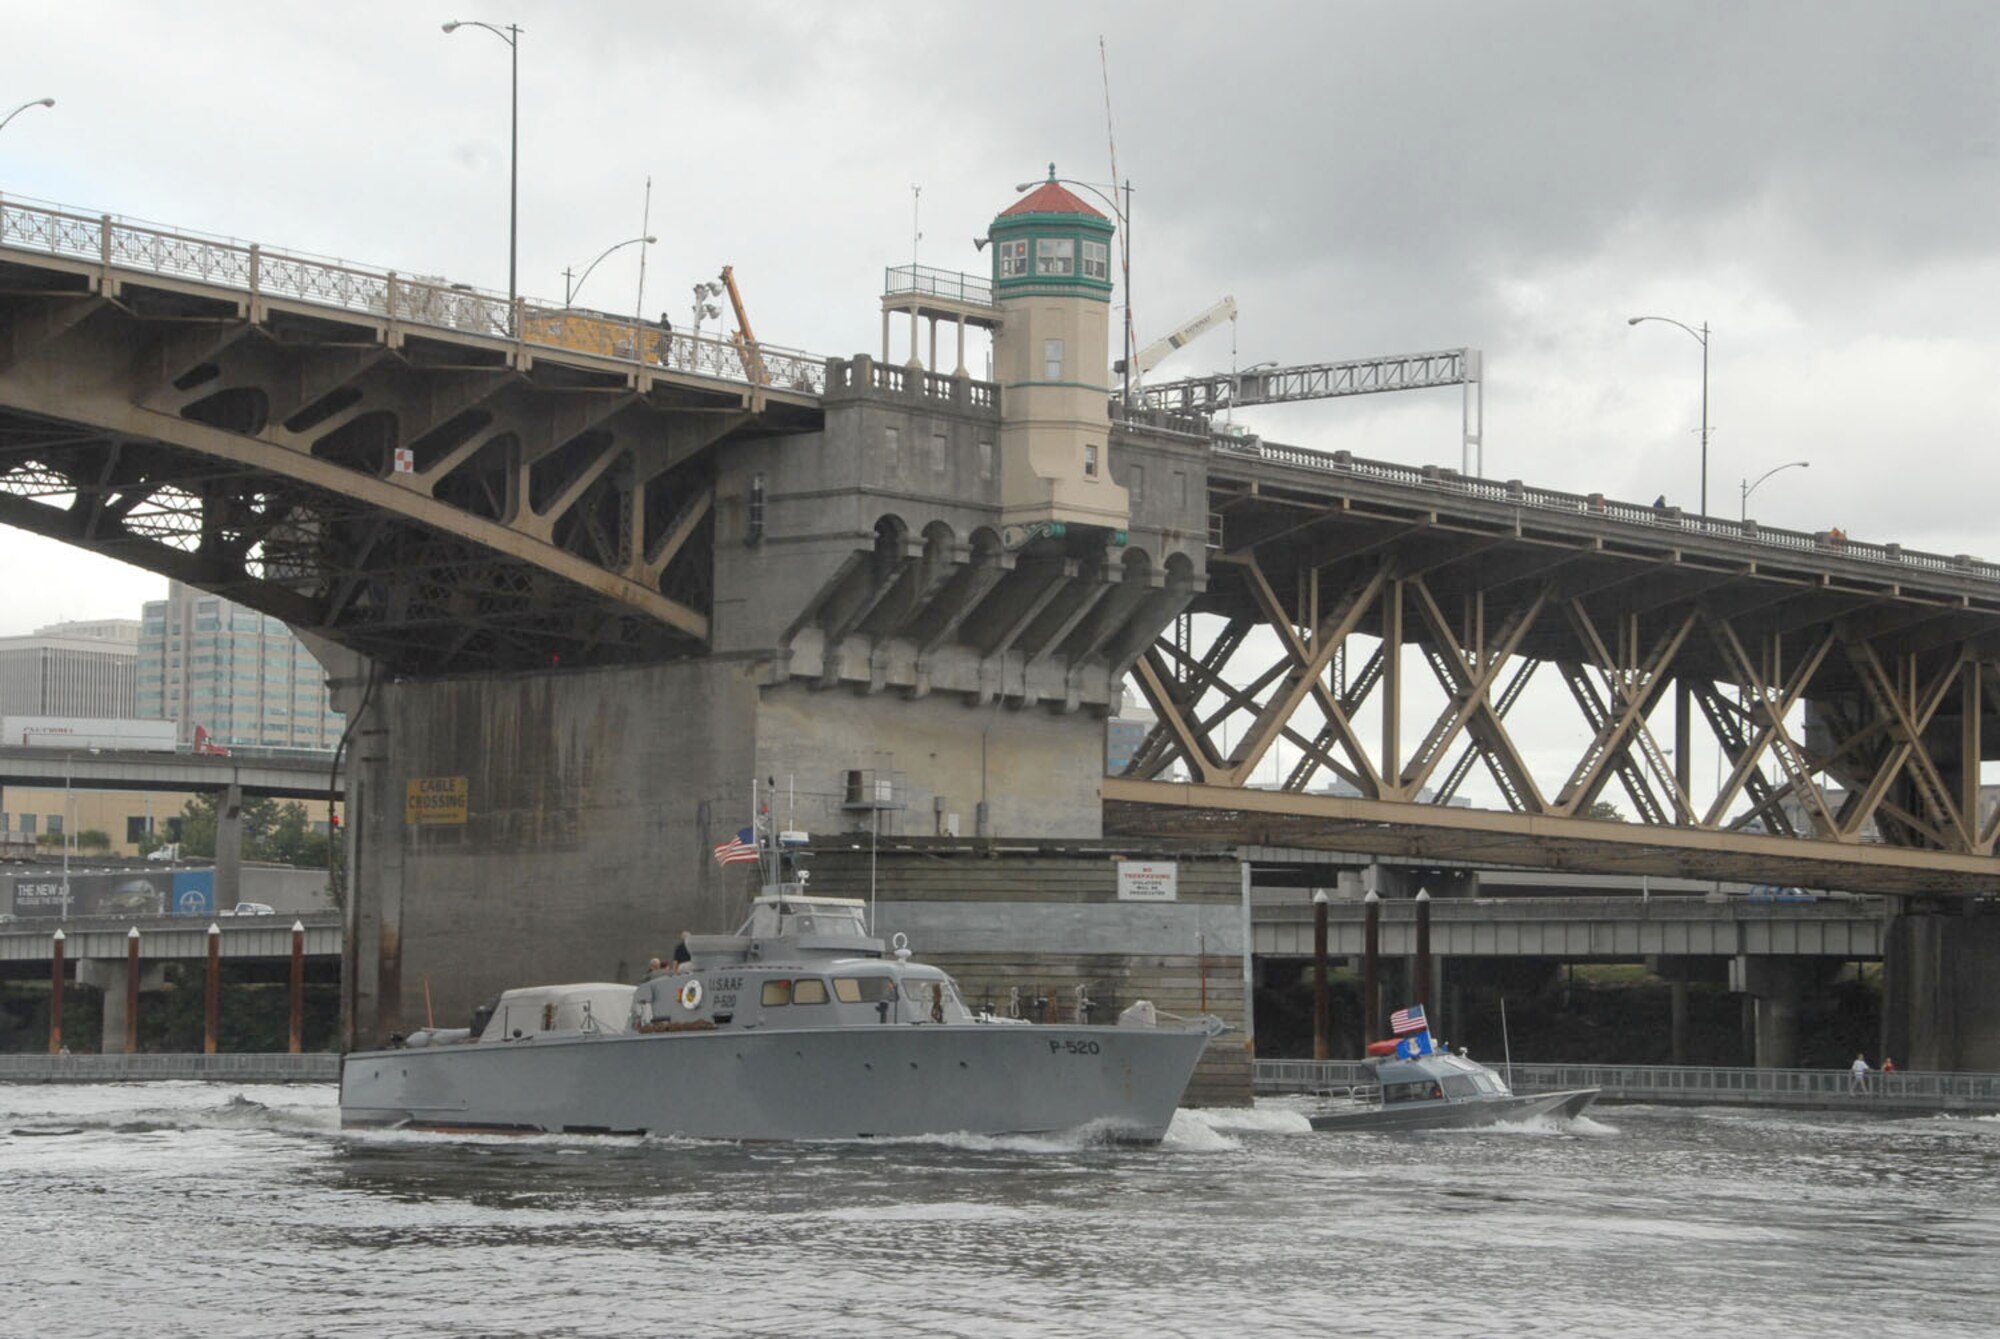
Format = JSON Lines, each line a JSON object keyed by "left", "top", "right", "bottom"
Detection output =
{"left": 1882, "top": 897, "right": 2000, "bottom": 1071}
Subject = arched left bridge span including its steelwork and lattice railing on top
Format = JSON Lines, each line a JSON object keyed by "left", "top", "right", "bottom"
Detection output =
{"left": 0, "top": 202, "right": 824, "bottom": 673}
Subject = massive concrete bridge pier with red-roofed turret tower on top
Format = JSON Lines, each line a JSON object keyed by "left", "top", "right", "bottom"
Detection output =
{"left": 336, "top": 175, "right": 1208, "bottom": 1043}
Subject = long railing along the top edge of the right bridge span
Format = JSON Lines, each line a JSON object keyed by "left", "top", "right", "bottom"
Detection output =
{"left": 1210, "top": 432, "right": 2000, "bottom": 582}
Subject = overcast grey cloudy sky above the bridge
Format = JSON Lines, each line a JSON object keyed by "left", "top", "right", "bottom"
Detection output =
{"left": 0, "top": 0, "right": 2000, "bottom": 634}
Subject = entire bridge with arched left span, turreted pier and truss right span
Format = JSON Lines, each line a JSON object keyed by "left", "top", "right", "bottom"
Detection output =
{"left": 0, "top": 182, "right": 2000, "bottom": 1067}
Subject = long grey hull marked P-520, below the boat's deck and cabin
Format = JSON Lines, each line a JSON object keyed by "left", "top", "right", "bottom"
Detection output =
{"left": 340, "top": 1023, "right": 1208, "bottom": 1143}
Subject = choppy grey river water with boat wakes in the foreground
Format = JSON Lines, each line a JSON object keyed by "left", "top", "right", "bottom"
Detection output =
{"left": 0, "top": 1083, "right": 2000, "bottom": 1339}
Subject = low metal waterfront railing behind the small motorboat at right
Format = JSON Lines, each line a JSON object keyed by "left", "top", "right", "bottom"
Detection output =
{"left": 1254, "top": 1059, "right": 2000, "bottom": 1115}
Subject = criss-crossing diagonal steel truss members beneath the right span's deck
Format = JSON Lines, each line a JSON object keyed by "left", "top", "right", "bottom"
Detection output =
{"left": 1124, "top": 550, "right": 2000, "bottom": 867}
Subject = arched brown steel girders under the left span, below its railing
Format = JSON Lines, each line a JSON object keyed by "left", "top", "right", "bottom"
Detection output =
{"left": 0, "top": 294, "right": 796, "bottom": 673}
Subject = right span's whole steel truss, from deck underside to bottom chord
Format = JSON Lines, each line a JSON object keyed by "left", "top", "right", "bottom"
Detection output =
{"left": 1106, "top": 458, "right": 2000, "bottom": 891}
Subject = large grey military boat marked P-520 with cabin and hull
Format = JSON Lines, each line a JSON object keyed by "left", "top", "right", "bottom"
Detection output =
{"left": 340, "top": 883, "right": 1220, "bottom": 1143}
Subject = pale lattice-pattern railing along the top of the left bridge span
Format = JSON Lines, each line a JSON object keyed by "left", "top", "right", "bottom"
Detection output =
{"left": 0, "top": 198, "right": 826, "bottom": 396}
